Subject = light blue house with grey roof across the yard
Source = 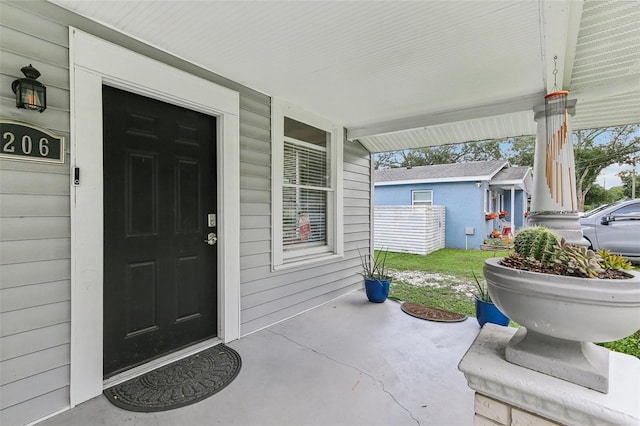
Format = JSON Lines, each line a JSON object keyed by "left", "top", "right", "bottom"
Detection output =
{"left": 374, "top": 160, "right": 532, "bottom": 249}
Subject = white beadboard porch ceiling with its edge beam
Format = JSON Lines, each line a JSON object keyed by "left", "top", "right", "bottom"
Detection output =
{"left": 49, "top": 0, "right": 640, "bottom": 152}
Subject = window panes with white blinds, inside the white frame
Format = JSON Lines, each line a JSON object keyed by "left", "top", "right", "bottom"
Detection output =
{"left": 282, "top": 117, "right": 331, "bottom": 252}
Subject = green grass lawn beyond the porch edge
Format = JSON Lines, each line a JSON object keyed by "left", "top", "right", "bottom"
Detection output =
{"left": 386, "top": 249, "right": 640, "bottom": 358}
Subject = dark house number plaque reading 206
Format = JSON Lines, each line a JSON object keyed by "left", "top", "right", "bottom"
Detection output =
{"left": 0, "top": 119, "right": 65, "bottom": 163}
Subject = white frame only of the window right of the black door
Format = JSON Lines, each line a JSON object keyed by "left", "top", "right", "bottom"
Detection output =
{"left": 271, "top": 98, "right": 344, "bottom": 270}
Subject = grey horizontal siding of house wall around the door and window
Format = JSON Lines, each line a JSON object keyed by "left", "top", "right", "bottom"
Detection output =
{"left": 0, "top": 2, "right": 372, "bottom": 425}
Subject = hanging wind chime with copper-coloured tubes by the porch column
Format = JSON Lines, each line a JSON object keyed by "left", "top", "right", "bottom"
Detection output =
{"left": 544, "top": 56, "right": 575, "bottom": 211}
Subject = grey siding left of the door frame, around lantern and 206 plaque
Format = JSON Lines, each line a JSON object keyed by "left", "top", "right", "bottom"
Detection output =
{"left": 0, "top": 2, "right": 71, "bottom": 425}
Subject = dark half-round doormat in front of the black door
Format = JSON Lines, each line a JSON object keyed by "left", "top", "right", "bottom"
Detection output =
{"left": 104, "top": 344, "right": 242, "bottom": 413}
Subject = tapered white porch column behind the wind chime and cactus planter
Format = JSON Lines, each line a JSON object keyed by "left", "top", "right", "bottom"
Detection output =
{"left": 529, "top": 100, "right": 587, "bottom": 245}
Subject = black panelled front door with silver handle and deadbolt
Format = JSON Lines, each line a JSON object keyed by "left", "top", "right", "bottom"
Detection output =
{"left": 103, "top": 86, "right": 217, "bottom": 377}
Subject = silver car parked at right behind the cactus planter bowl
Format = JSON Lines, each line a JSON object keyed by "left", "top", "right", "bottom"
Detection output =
{"left": 580, "top": 199, "right": 640, "bottom": 261}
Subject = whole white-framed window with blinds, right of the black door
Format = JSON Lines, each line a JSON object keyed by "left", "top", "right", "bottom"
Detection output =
{"left": 271, "top": 98, "right": 344, "bottom": 271}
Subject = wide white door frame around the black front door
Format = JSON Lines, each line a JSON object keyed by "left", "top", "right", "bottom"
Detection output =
{"left": 69, "top": 27, "right": 240, "bottom": 406}
